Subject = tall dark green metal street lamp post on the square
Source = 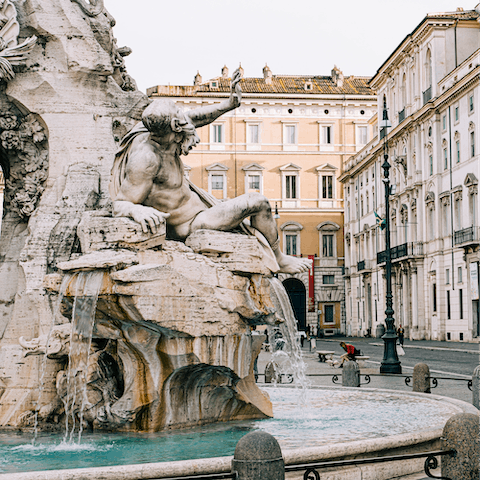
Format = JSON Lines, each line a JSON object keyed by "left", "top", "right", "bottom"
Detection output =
{"left": 379, "top": 102, "right": 402, "bottom": 373}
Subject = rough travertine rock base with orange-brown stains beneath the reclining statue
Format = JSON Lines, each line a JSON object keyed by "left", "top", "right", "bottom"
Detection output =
{"left": 21, "top": 213, "right": 280, "bottom": 431}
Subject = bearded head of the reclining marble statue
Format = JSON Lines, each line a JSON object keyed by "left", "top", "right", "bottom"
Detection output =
{"left": 142, "top": 99, "right": 200, "bottom": 155}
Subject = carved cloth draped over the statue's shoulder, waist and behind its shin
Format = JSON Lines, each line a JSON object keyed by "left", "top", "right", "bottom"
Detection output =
{"left": 109, "top": 122, "right": 280, "bottom": 273}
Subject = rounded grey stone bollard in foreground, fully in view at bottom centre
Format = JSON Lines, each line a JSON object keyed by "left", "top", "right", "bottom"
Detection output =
{"left": 232, "top": 431, "right": 285, "bottom": 480}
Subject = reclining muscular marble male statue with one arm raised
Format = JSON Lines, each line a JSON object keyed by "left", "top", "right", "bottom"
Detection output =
{"left": 110, "top": 70, "right": 311, "bottom": 274}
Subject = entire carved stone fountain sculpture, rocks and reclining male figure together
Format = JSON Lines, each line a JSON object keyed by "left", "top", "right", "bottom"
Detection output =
{"left": 0, "top": 0, "right": 309, "bottom": 439}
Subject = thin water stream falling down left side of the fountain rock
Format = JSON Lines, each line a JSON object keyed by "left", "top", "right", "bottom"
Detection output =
{"left": 63, "top": 271, "right": 104, "bottom": 443}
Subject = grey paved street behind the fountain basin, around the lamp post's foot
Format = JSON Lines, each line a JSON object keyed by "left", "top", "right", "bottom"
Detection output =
{"left": 258, "top": 337, "right": 480, "bottom": 403}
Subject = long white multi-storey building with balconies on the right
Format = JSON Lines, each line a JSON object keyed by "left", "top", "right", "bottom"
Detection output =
{"left": 340, "top": 9, "right": 480, "bottom": 341}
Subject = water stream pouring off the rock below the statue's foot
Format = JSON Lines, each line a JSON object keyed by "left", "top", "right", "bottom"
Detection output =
{"left": 268, "top": 277, "right": 309, "bottom": 402}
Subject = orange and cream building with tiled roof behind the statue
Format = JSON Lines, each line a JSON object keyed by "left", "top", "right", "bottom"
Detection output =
{"left": 147, "top": 66, "right": 376, "bottom": 335}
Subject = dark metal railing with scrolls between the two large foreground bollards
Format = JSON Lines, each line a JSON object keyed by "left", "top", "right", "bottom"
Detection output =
{"left": 285, "top": 450, "right": 456, "bottom": 480}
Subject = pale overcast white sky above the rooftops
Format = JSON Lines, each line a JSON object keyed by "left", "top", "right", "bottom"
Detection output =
{"left": 105, "top": 0, "right": 480, "bottom": 91}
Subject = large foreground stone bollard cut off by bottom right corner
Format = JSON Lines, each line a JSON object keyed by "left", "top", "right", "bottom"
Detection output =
{"left": 442, "top": 413, "right": 480, "bottom": 480}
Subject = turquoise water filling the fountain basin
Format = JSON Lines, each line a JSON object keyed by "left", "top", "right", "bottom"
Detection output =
{"left": 0, "top": 387, "right": 460, "bottom": 473}
